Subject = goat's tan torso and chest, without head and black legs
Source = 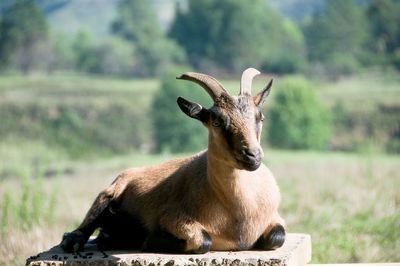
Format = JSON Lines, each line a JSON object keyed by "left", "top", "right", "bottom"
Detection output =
{"left": 77, "top": 152, "right": 282, "bottom": 250}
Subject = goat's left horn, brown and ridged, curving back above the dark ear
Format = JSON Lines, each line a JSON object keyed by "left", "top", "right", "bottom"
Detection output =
{"left": 177, "top": 72, "right": 227, "bottom": 101}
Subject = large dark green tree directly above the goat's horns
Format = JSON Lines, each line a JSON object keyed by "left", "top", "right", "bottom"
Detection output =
{"left": 169, "top": 0, "right": 304, "bottom": 72}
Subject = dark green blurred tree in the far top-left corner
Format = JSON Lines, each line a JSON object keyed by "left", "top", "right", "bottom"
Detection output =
{"left": 0, "top": 0, "right": 48, "bottom": 73}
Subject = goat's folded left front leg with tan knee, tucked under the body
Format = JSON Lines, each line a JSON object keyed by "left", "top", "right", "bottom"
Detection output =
{"left": 143, "top": 218, "right": 212, "bottom": 254}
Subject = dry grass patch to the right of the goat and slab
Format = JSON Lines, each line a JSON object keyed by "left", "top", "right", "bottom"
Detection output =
{"left": 271, "top": 152, "right": 400, "bottom": 263}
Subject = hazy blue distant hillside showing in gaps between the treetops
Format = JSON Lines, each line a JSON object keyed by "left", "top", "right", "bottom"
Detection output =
{"left": 0, "top": 0, "right": 371, "bottom": 38}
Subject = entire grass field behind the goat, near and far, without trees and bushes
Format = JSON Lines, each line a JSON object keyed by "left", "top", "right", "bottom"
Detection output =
{"left": 0, "top": 73, "right": 400, "bottom": 265}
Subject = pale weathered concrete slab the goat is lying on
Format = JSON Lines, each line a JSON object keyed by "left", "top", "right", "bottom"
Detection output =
{"left": 26, "top": 234, "right": 311, "bottom": 266}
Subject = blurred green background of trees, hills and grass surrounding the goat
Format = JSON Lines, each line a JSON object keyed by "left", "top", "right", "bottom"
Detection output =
{"left": 0, "top": 0, "right": 400, "bottom": 265}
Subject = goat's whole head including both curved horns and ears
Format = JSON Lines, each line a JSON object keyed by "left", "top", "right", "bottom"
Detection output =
{"left": 177, "top": 68, "right": 272, "bottom": 171}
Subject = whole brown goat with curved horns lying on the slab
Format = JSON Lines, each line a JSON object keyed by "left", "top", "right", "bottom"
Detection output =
{"left": 61, "top": 68, "right": 285, "bottom": 253}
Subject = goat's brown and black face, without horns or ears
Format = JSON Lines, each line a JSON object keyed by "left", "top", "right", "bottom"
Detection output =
{"left": 205, "top": 95, "right": 263, "bottom": 171}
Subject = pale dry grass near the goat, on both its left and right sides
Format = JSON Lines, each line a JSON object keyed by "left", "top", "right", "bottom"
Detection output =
{"left": 0, "top": 150, "right": 400, "bottom": 265}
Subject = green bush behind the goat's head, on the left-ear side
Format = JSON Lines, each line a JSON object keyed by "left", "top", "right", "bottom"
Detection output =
{"left": 152, "top": 68, "right": 210, "bottom": 152}
